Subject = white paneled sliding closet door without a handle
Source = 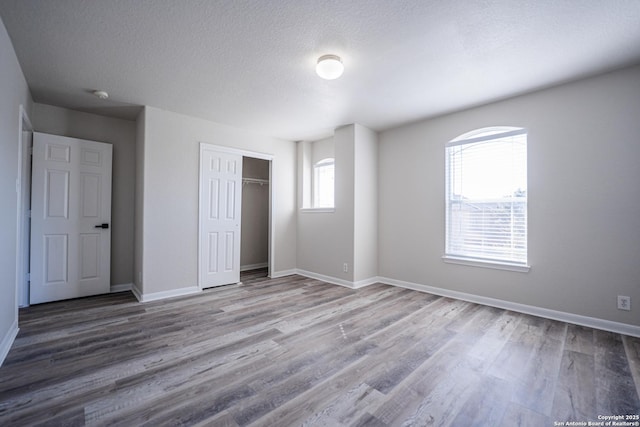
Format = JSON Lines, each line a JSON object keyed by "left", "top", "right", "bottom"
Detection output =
{"left": 199, "top": 144, "right": 242, "bottom": 289}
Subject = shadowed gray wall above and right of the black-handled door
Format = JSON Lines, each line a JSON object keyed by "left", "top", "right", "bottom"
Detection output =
{"left": 32, "top": 103, "right": 136, "bottom": 286}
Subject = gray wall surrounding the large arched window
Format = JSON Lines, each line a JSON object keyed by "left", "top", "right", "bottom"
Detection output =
{"left": 378, "top": 66, "right": 640, "bottom": 325}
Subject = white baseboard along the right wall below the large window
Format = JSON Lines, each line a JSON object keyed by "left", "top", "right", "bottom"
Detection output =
{"left": 379, "top": 277, "right": 640, "bottom": 338}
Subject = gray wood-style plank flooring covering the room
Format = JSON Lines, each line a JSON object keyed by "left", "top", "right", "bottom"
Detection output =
{"left": 0, "top": 271, "right": 640, "bottom": 427}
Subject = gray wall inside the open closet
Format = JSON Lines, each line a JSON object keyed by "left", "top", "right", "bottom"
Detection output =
{"left": 240, "top": 157, "right": 269, "bottom": 269}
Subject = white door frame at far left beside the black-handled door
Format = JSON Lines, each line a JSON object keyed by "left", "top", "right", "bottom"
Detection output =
{"left": 16, "top": 105, "right": 33, "bottom": 307}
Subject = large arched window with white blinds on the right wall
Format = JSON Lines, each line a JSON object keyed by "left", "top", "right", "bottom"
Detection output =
{"left": 445, "top": 127, "right": 527, "bottom": 267}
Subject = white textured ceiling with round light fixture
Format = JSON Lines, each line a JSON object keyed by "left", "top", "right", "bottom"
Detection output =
{"left": 0, "top": 0, "right": 640, "bottom": 140}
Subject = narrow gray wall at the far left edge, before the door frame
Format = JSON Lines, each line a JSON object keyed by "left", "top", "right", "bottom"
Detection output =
{"left": 0, "top": 16, "right": 32, "bottom": 364}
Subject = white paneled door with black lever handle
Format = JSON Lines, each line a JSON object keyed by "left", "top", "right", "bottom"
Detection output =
{"left": 29, "top": 132, "right": 112, "bottom": 304}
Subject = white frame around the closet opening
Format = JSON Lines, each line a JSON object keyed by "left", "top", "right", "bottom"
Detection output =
{"left": 198, "top": 142, "right": 275, "bottom": 290}
